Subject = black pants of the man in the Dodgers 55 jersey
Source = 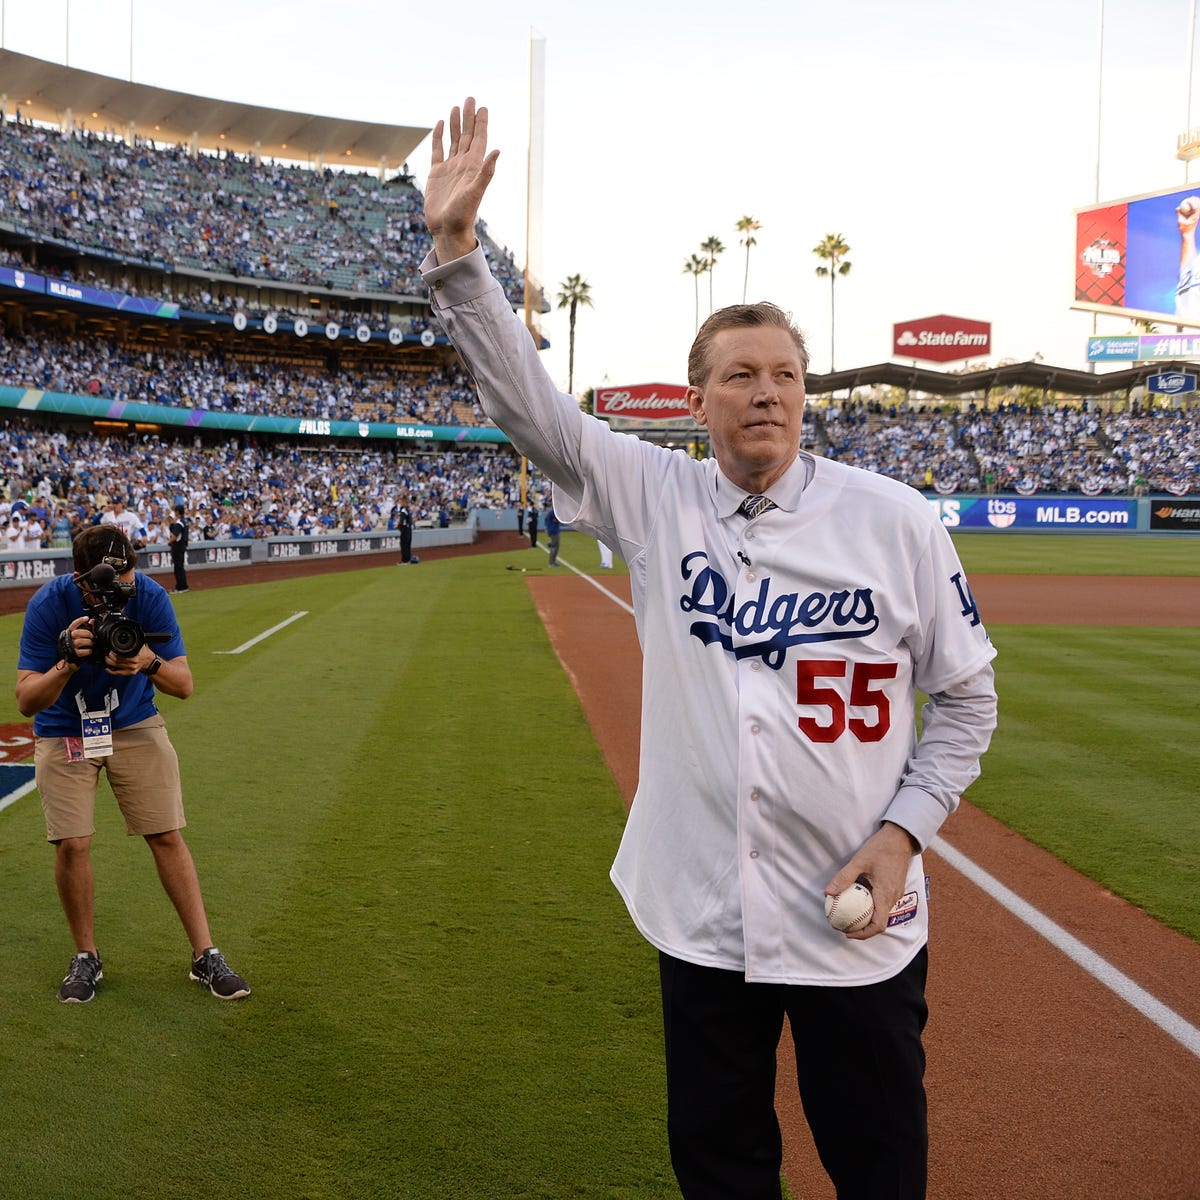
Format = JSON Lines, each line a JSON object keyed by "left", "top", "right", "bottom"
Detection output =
{"left": 659, "top": 949, "right": 929, "bottom": 1200}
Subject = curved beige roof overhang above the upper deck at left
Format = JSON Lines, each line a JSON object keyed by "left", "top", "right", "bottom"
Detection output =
{"left": 0, "top": 49, "right": 430, "bottom": 170}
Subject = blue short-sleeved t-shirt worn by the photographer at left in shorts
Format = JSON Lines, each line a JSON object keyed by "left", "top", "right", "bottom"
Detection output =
{"left": 17, "top": 571, "right": 187, "bottom": 738}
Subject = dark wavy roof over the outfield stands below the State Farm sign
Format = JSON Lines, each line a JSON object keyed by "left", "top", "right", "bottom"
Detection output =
{"left": 804, "top": 362, "right": 1198, "bottom": 396}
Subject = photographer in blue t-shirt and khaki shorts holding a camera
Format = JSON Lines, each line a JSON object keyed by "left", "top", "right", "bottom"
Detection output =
{"left": 17, "top": 524, "right": 250, "bottom": 1003}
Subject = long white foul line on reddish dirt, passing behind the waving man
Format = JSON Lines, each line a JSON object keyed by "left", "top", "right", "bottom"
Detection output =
{"left": 549, "top": 559, "right": 1200, "bottom": 1058}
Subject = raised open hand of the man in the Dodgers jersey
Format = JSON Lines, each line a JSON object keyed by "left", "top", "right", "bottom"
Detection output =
{"left": 425, "top": 96, "right": 500, "bottom": 263}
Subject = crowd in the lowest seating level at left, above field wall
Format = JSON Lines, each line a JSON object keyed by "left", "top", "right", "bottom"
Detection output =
{"left": 0, "top": 420, "right": 542, "bottom": 551}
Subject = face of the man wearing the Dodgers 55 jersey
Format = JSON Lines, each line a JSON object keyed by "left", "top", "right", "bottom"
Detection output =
{"left": 688, "top": 325, "right": 804, "bottom": 493}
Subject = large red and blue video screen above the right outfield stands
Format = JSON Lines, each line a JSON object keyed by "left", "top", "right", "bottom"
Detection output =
{"left": 1072, "top": 185, "right": 1200, "bottom": 328}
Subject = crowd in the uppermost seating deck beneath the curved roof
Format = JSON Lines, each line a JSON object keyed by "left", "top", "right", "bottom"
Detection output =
{"left": 0, "top": 116, "right": 524, "bottom": 302}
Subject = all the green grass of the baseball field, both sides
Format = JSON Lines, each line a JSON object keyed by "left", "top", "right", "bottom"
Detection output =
{"left": 0, "top": 535, "right": 1200, "bottom": 1200}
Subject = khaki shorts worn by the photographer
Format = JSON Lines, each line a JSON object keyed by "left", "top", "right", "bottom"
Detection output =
{"left": 34, "top": 716, "right": 187, "bottom": 841}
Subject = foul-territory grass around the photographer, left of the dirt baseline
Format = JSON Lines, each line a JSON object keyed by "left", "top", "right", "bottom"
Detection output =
{"left": 0, "top": 559, "right": 676, "bottom": 1198}
